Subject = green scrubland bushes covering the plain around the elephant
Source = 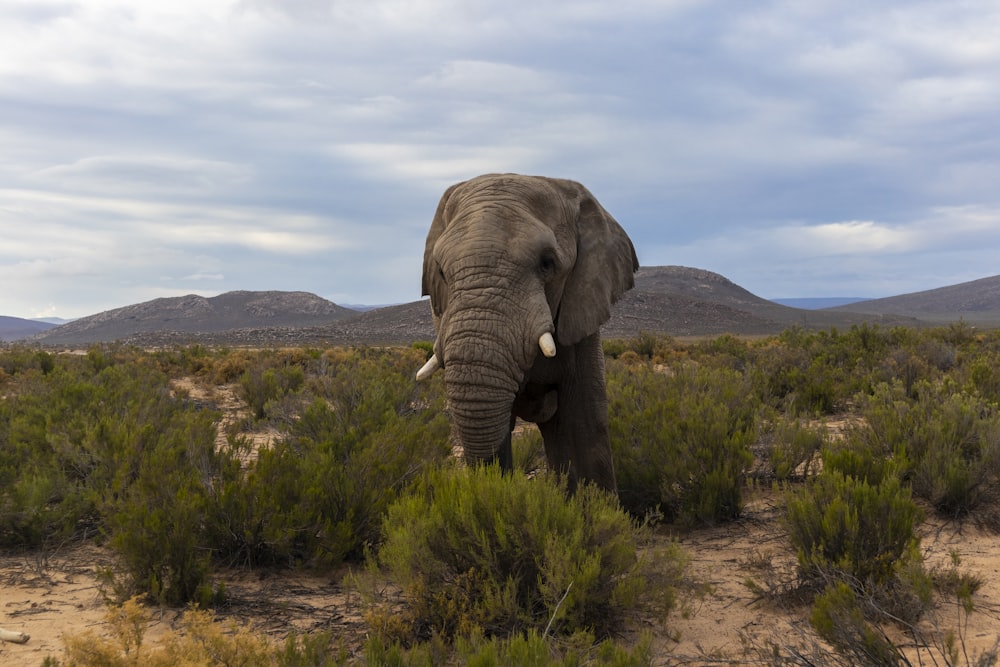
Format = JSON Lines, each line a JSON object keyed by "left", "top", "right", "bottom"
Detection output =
{"left": 0, "top": 324, "right": 1000, "bottom": 665}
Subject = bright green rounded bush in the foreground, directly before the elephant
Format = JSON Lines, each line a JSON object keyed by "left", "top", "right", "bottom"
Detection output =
{"left": 378, "top": 466, "right": 656, "bottom": 638}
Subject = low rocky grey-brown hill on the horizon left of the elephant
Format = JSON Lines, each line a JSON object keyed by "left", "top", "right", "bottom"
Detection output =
{"left": 32, "top": 291, "right": 357, "bottom": 345}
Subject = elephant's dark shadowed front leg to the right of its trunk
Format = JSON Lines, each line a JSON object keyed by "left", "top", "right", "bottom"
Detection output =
{"left": 538, "top": 334, "right": 617, "bottom": 491}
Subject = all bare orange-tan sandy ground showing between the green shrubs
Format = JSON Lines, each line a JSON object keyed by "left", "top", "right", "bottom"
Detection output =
{"left": 0, "top": 332, "right": 1000, "bottom": 665}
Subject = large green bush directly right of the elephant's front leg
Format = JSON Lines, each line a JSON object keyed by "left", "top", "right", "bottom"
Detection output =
{"left": 608, "top": 362, "right": 760, "bottom": 523}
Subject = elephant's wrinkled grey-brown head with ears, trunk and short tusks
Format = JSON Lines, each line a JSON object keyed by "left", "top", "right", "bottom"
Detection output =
{"left": 418, "top": 174, "right": 638, "bottom": 470}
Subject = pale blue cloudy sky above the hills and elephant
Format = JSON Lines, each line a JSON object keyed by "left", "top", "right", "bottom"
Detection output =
{"left": 0, "top": 0, "right": 1000, "bottom": 318}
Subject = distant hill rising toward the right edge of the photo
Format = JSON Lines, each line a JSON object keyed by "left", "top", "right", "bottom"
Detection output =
{"left": 830, "top": 276, "right": 1000, "bottom": 327}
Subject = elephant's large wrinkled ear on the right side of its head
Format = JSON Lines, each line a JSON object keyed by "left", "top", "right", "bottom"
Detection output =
{"left": 556, "top": 186, "right": 639, "bottom": 345}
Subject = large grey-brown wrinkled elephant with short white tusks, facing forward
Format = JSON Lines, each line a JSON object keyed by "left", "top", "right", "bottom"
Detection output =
{"left": 417, "top": 174, "right": 639, "bottom": 493}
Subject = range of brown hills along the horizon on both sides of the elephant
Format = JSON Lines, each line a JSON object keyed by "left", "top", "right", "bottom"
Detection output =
{"left": 7, "top": 266, "right": 1000, "bottom": 346}
